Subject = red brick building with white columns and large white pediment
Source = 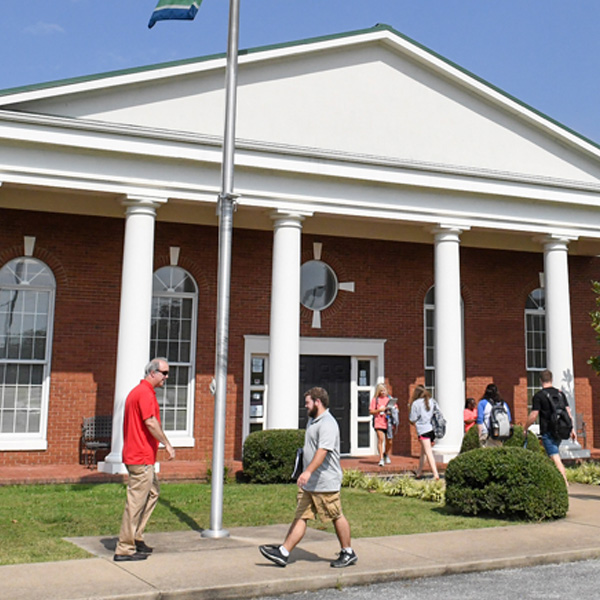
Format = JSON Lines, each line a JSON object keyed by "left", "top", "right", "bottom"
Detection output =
{"left": 0, "top": 26, "right": 600, "bottom": 471}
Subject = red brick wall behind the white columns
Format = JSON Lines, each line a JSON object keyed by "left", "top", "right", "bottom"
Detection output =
{"left": 0, "top": 210, "right": 600, "bottom": 466}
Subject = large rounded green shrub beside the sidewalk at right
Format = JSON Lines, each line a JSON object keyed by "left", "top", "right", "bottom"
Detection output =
{"left": 446, "top": 447, "right": 569, "bottom": 521}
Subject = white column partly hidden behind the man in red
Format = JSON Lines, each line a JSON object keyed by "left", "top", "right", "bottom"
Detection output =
{"left": 98, "top": 197, "right": 165, "bottom": 473}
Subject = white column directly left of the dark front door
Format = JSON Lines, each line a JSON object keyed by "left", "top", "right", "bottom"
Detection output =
{"left": 267, "top": 211, "right": 307, "bottom": 429}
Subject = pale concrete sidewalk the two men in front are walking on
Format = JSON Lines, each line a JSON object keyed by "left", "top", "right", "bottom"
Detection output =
{"left": 0, "top": 484, "right": 600, "bottom": 600}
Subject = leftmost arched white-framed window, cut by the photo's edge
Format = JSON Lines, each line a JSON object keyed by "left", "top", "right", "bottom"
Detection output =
{"left": 0, "top": 257, "right": 56, "bottom": 450}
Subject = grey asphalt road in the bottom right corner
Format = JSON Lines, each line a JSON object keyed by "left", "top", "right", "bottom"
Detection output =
{"left": 263, "top": 556, "right": 600, "bottom": 600}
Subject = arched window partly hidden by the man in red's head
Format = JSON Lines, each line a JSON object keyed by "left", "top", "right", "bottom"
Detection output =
{"left": 150, "top": 267, "right": 198, "bottom": 446}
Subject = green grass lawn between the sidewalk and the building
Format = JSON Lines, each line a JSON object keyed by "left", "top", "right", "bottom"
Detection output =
{"left": 0, "top": 483, "right": 509, "bottom": 564}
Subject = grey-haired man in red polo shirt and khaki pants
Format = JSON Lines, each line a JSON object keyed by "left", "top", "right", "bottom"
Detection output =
{"left": 113, "top": 358, "right": 175, "bottom": 561}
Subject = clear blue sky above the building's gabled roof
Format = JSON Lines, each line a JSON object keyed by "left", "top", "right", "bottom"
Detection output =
{"left": 0, "top": 0, "right": 600, "bottom": 143}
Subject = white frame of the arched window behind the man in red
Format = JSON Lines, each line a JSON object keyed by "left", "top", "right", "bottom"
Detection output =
{"left": 150, "top": 265, "right": 199, "bottom": 448}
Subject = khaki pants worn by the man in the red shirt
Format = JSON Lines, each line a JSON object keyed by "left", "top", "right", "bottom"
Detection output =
{"left": 115, "top": 465, "right": 160, "bottom": 554}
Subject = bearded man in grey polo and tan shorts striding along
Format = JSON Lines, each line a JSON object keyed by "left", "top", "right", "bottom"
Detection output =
{"left": 259, "top": 387, "right": 358, "bottom": 568}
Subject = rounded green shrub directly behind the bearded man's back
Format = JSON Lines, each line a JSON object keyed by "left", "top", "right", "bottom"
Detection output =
{"left": 242, "top": 429, "right": 304, "bottom": 483}
